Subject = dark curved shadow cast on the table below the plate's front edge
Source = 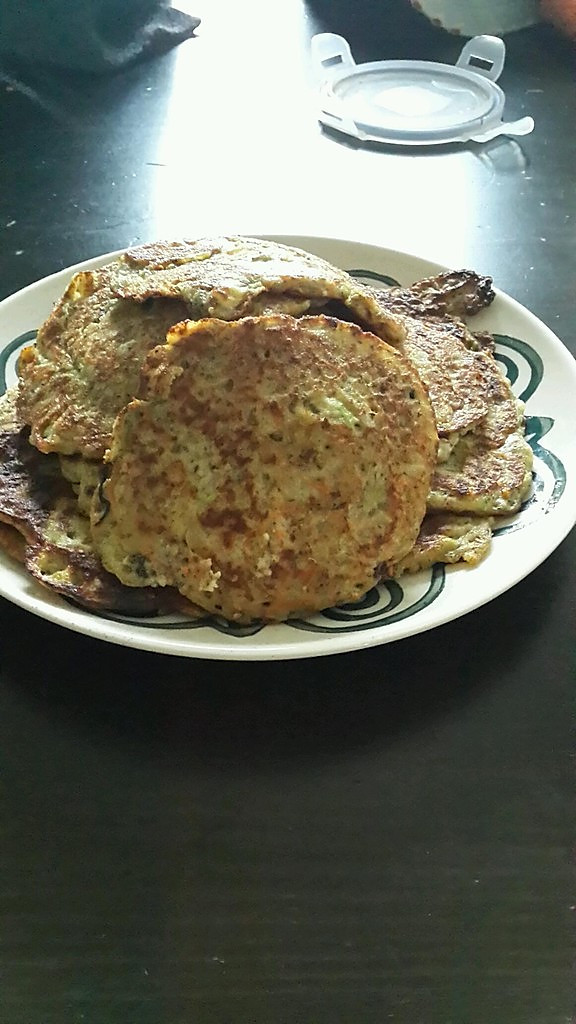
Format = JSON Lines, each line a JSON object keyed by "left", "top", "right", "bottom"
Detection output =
{"left": 0, "top": 557, "right": 557, "bottom": 770}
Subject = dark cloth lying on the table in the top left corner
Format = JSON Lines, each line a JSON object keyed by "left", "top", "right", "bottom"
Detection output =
{"left": 0, "top": 0, "right": 200, "bottom": 74}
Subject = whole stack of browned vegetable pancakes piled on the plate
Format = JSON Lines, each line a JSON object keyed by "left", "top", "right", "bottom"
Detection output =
{"left": 0, "top": 237, "right": 532, "bottom": 622}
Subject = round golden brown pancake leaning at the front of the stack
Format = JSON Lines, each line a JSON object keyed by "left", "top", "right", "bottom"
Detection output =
{"left": 92, "top": 315, "right": 437, "bottom": 622}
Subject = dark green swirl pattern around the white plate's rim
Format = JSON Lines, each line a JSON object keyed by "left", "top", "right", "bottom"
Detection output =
{"left": 0, "top": 269, "right": 566, "bottom": 637}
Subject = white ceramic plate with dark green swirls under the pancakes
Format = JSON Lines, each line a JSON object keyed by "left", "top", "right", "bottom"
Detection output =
{"left": 0, "top": 237, "right": 576, "bottom": 660}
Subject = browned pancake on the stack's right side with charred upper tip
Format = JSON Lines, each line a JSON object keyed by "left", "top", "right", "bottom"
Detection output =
{"left": 380, "top": 271, "right": 533, "bottom": 516}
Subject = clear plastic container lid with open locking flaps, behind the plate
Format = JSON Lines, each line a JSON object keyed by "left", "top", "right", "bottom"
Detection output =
{"left": 312, "top": 33, "right": 534, "bottom": 145}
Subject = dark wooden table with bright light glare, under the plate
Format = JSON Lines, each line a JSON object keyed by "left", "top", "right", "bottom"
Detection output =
{"left": 0, "top": 0, "right": 576, "bottom": 1024}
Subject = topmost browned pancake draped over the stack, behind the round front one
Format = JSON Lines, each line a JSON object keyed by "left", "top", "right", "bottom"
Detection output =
{"left": 18, "top": 238, "right": 403, "bottom": 460}
